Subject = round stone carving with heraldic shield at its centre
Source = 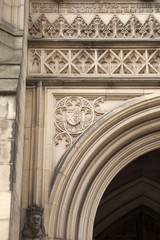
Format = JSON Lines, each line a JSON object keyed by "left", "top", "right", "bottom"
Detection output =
{"left": 54, "top": 97, "right": 94, "bottom": 135}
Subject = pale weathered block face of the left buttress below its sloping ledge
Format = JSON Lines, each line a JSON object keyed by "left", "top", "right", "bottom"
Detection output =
{"left": 0, "top": 95, "right": 16, "bottom": 240}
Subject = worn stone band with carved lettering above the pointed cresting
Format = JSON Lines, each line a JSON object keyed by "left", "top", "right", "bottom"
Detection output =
{"left": 30, "top": 0, "right": 160, "bottom": 14}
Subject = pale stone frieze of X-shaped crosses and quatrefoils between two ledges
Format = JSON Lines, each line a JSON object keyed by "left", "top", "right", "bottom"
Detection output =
{"left": 29, "top": 49, "right": 160, "bottom": 77}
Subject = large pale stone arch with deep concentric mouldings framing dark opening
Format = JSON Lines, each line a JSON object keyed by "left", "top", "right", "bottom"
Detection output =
{"left": 48, "top": 94, "right": 160, "bottom": 240}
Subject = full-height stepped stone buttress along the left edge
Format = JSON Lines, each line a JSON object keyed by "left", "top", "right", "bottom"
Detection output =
{"left": 0, "top": 0, "right": 26, "bottom": 240}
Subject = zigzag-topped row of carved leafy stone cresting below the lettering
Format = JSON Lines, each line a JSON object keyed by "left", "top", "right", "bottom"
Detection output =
{"left": 29, "top": 14, "right": 160, "bottom": 39}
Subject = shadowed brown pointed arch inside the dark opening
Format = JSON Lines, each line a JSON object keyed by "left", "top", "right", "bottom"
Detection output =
{"left": 94, "top": 177, "right": 160, "bottom": 237}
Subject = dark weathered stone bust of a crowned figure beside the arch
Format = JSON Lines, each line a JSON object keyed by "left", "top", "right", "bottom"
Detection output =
{"left": 22, "top": 205, "right": 47, "bottom": 240}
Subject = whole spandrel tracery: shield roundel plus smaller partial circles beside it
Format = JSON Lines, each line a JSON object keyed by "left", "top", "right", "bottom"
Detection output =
{"left": 54, "top": 96, "right": 108, "bottom": 149}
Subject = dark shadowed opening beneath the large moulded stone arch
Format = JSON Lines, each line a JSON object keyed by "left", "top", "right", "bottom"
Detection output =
{"left": 93, "top": 149, "right": 160, "bottom": 240}
